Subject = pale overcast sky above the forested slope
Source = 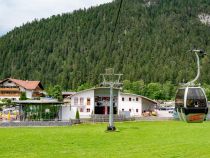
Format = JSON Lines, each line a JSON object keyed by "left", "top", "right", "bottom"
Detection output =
{"left": 0, "top": 0, "right": 112, "bottom": 36}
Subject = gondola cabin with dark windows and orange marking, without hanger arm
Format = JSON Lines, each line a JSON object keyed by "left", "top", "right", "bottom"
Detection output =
{"left": 175, "top": 87, "right": 208, "bottom": 122}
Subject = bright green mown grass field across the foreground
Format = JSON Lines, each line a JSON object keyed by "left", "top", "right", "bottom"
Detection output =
{"left": 0, "top": 121, "right": 210, "bottom": 158}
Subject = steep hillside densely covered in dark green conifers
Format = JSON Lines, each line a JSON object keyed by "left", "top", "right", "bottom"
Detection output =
{"left": 0, "top": 0, "right": 210, "bottom": 89}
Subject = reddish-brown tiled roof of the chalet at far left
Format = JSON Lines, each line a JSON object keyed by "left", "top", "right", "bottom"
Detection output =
{"left": 0, "top": 78, "right": 43, "bottom": 90}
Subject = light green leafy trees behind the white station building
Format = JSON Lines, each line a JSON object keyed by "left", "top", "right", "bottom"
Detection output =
{"left": 51, "top": 80, "right": 210, "bottom": 100}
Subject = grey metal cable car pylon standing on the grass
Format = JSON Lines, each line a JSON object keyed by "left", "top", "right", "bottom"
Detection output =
{"left": 101, "top": 68, "right": 123, "bottom": 131}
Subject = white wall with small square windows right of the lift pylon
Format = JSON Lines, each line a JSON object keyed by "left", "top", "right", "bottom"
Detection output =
{"left": 118, "top": 93, "right": 142, "bottom": 116}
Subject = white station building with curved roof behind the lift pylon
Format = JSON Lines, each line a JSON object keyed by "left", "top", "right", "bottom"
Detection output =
{"left": 61, "top": 87, "right": 157, "bottom": 120}
